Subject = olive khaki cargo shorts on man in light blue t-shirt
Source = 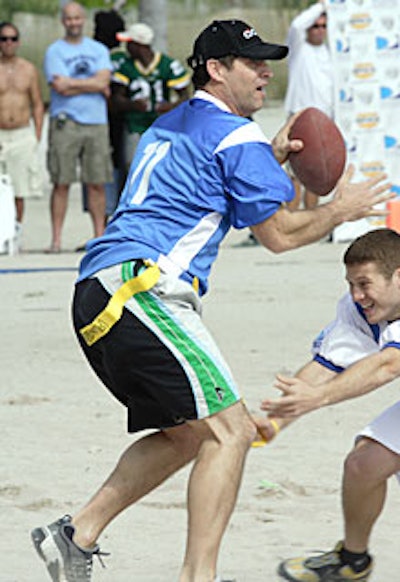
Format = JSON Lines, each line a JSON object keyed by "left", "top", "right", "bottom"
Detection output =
{"left": 47, "top": 118, "right": 112, "bottom": 184}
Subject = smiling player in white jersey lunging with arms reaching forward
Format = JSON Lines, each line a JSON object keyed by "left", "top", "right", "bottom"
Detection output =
{"left": 262, "top": 229, "right": 400, "bottom": 582}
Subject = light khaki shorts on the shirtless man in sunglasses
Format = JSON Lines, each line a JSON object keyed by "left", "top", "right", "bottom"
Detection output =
{"left": 0, "top": 125, "right": 43, "bottom": 198}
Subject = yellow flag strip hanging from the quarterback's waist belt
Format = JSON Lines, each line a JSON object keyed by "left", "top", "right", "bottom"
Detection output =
{"left": 79, "top": 261, "right": 160, "bottom": 346}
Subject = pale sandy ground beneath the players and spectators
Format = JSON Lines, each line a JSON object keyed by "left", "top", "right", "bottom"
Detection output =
{"left": 0, "top": 106, "right": 400, "bottom": 582}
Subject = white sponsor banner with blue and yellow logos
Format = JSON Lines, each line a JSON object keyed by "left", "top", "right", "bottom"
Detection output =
{"left": 326, "top": 0, "right": 400, "bottom": 241}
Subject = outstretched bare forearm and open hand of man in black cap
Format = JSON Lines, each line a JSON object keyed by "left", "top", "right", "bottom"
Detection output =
{"left": 251, "top": 166, "right": 395, "bottom": 253}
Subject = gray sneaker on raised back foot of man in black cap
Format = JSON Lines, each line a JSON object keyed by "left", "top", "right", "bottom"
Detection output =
{"left": 31, "top": 515, "right": 108, "bottom": 582}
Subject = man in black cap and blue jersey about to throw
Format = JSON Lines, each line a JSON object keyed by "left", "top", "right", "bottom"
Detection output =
{"left": 32, "top": 20, "right": 391, "bottom": 582}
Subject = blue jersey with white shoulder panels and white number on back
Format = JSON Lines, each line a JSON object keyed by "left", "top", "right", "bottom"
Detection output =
{"left": 79, "top": 91, "right": 294, "bottom": 294}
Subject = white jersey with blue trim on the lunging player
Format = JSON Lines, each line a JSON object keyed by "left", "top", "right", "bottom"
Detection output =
{"left": 312, "top": 293, "right": 400, "bottom": 372}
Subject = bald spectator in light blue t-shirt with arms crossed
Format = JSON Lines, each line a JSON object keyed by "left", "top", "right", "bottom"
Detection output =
{"left": 44, "top": 2, "right": 112, "bottom": 253}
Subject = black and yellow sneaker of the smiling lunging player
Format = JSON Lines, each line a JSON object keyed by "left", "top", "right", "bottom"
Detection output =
{"left": 278, "top": 542, "right": 373, "bottom": 582}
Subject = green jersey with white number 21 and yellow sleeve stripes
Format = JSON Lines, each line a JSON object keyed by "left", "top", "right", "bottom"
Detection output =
{"left": 113, "top": 52, "right": 190, "bottom": 133}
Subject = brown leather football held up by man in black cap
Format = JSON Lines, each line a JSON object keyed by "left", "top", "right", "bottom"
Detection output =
{"left": 288, "top": 107, "right": 346, "bottom": 196}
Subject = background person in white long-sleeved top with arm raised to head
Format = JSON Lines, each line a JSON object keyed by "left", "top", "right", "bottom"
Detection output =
{"left": 285, "top": 0, "right": 334, "bottom": 209}
